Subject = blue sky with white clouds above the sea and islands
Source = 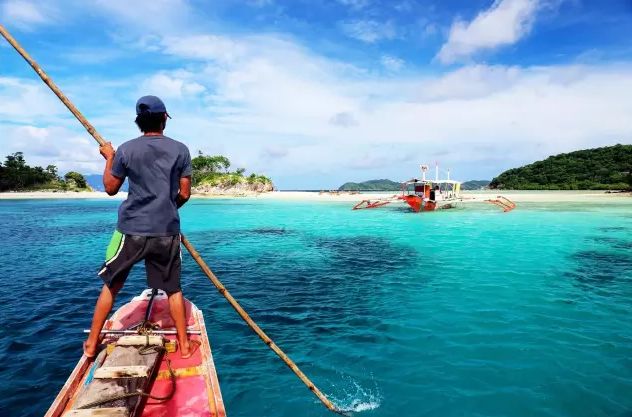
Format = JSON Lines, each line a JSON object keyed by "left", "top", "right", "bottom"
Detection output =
{"left": 0, "top": 0, "right": 632, "bottom": 189}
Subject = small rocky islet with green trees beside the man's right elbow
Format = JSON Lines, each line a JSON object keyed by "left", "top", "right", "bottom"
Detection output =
{"left": 191, "top": 151, "right": 274, "bottom": 195}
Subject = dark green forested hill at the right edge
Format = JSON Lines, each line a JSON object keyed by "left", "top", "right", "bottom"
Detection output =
{"left": 489, "top": 145, "right": 632, "bottom": 190}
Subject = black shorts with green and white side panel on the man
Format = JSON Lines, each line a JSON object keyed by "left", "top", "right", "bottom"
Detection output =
{"left": 99, "top": 230, "right": 182, "bottom": 294}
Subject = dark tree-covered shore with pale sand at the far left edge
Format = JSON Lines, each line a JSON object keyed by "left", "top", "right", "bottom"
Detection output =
{"left": 0, "top": 152, "right": 92, "bottom": 192}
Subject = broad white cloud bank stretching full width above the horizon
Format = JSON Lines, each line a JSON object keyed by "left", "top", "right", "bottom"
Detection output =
{"left": 0, "top": 27, "right": 632, "bottom": 188}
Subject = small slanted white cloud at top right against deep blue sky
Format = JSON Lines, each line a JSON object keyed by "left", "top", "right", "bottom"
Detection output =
{"left": 437, "top": 0, "right": 541, "bottom": 64}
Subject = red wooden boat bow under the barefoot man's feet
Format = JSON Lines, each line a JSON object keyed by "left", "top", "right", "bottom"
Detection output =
{"left": 45, "top": 289, "right": 226, "bottom": 417}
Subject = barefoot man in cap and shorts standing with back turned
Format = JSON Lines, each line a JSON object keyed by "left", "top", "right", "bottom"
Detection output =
{"left": 83, "top": 96, "right": 199, "bottom": 358}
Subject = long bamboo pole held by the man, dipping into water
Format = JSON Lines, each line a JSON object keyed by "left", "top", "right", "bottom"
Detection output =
{"left": 0, "top": 25, "right": 345, "bottom": 415}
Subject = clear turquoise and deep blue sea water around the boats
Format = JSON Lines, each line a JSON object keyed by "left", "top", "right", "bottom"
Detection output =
{"left": 0, "top": 200, "right": 632, "bottom": 417}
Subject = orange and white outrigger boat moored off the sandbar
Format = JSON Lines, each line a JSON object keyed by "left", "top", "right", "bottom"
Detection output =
{"left": 353, "top": 165, "right": 462, "bottom": 213}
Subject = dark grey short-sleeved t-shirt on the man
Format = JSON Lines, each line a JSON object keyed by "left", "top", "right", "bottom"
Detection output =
{"left": 111, "top": 136, "right": 191, "bottom": 236}
